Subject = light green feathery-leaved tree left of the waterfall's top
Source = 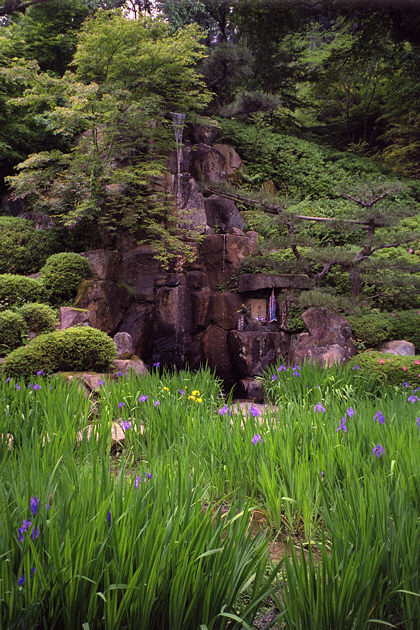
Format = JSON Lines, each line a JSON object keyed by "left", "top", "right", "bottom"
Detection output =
{"left": 8, "top": 11, "right": 210, "bottom": 260}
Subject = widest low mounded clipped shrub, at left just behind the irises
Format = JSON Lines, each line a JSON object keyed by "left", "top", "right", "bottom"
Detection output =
{"left": 1, "top": 326, "right": 116, "bottom": 378}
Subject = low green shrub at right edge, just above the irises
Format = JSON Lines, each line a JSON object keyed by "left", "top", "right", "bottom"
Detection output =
{"left": 347, "top": 351, "right": 420, "bottom": 387}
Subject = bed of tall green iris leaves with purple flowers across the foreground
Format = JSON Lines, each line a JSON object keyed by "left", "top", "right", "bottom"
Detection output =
{"left": 0, "top": 365, "right": 420, "bottom": 630}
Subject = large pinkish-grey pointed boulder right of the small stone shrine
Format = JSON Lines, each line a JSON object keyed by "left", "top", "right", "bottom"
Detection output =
{"left": 289, "top": 308, "right": 356, "bottom": 365}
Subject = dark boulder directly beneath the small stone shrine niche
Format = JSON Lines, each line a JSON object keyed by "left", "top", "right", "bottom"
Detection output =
{"left": 228, "top": 329, "right": 290, "bottom": 378}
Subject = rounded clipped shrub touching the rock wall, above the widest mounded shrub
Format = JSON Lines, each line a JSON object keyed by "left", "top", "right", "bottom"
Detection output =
{"left": 41, "top": 252, "right": 92, "bottom": 304}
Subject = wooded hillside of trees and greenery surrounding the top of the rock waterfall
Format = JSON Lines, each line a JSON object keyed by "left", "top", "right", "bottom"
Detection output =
{"left": 0, "top": 0, "right": 420, "bottom": 320}
